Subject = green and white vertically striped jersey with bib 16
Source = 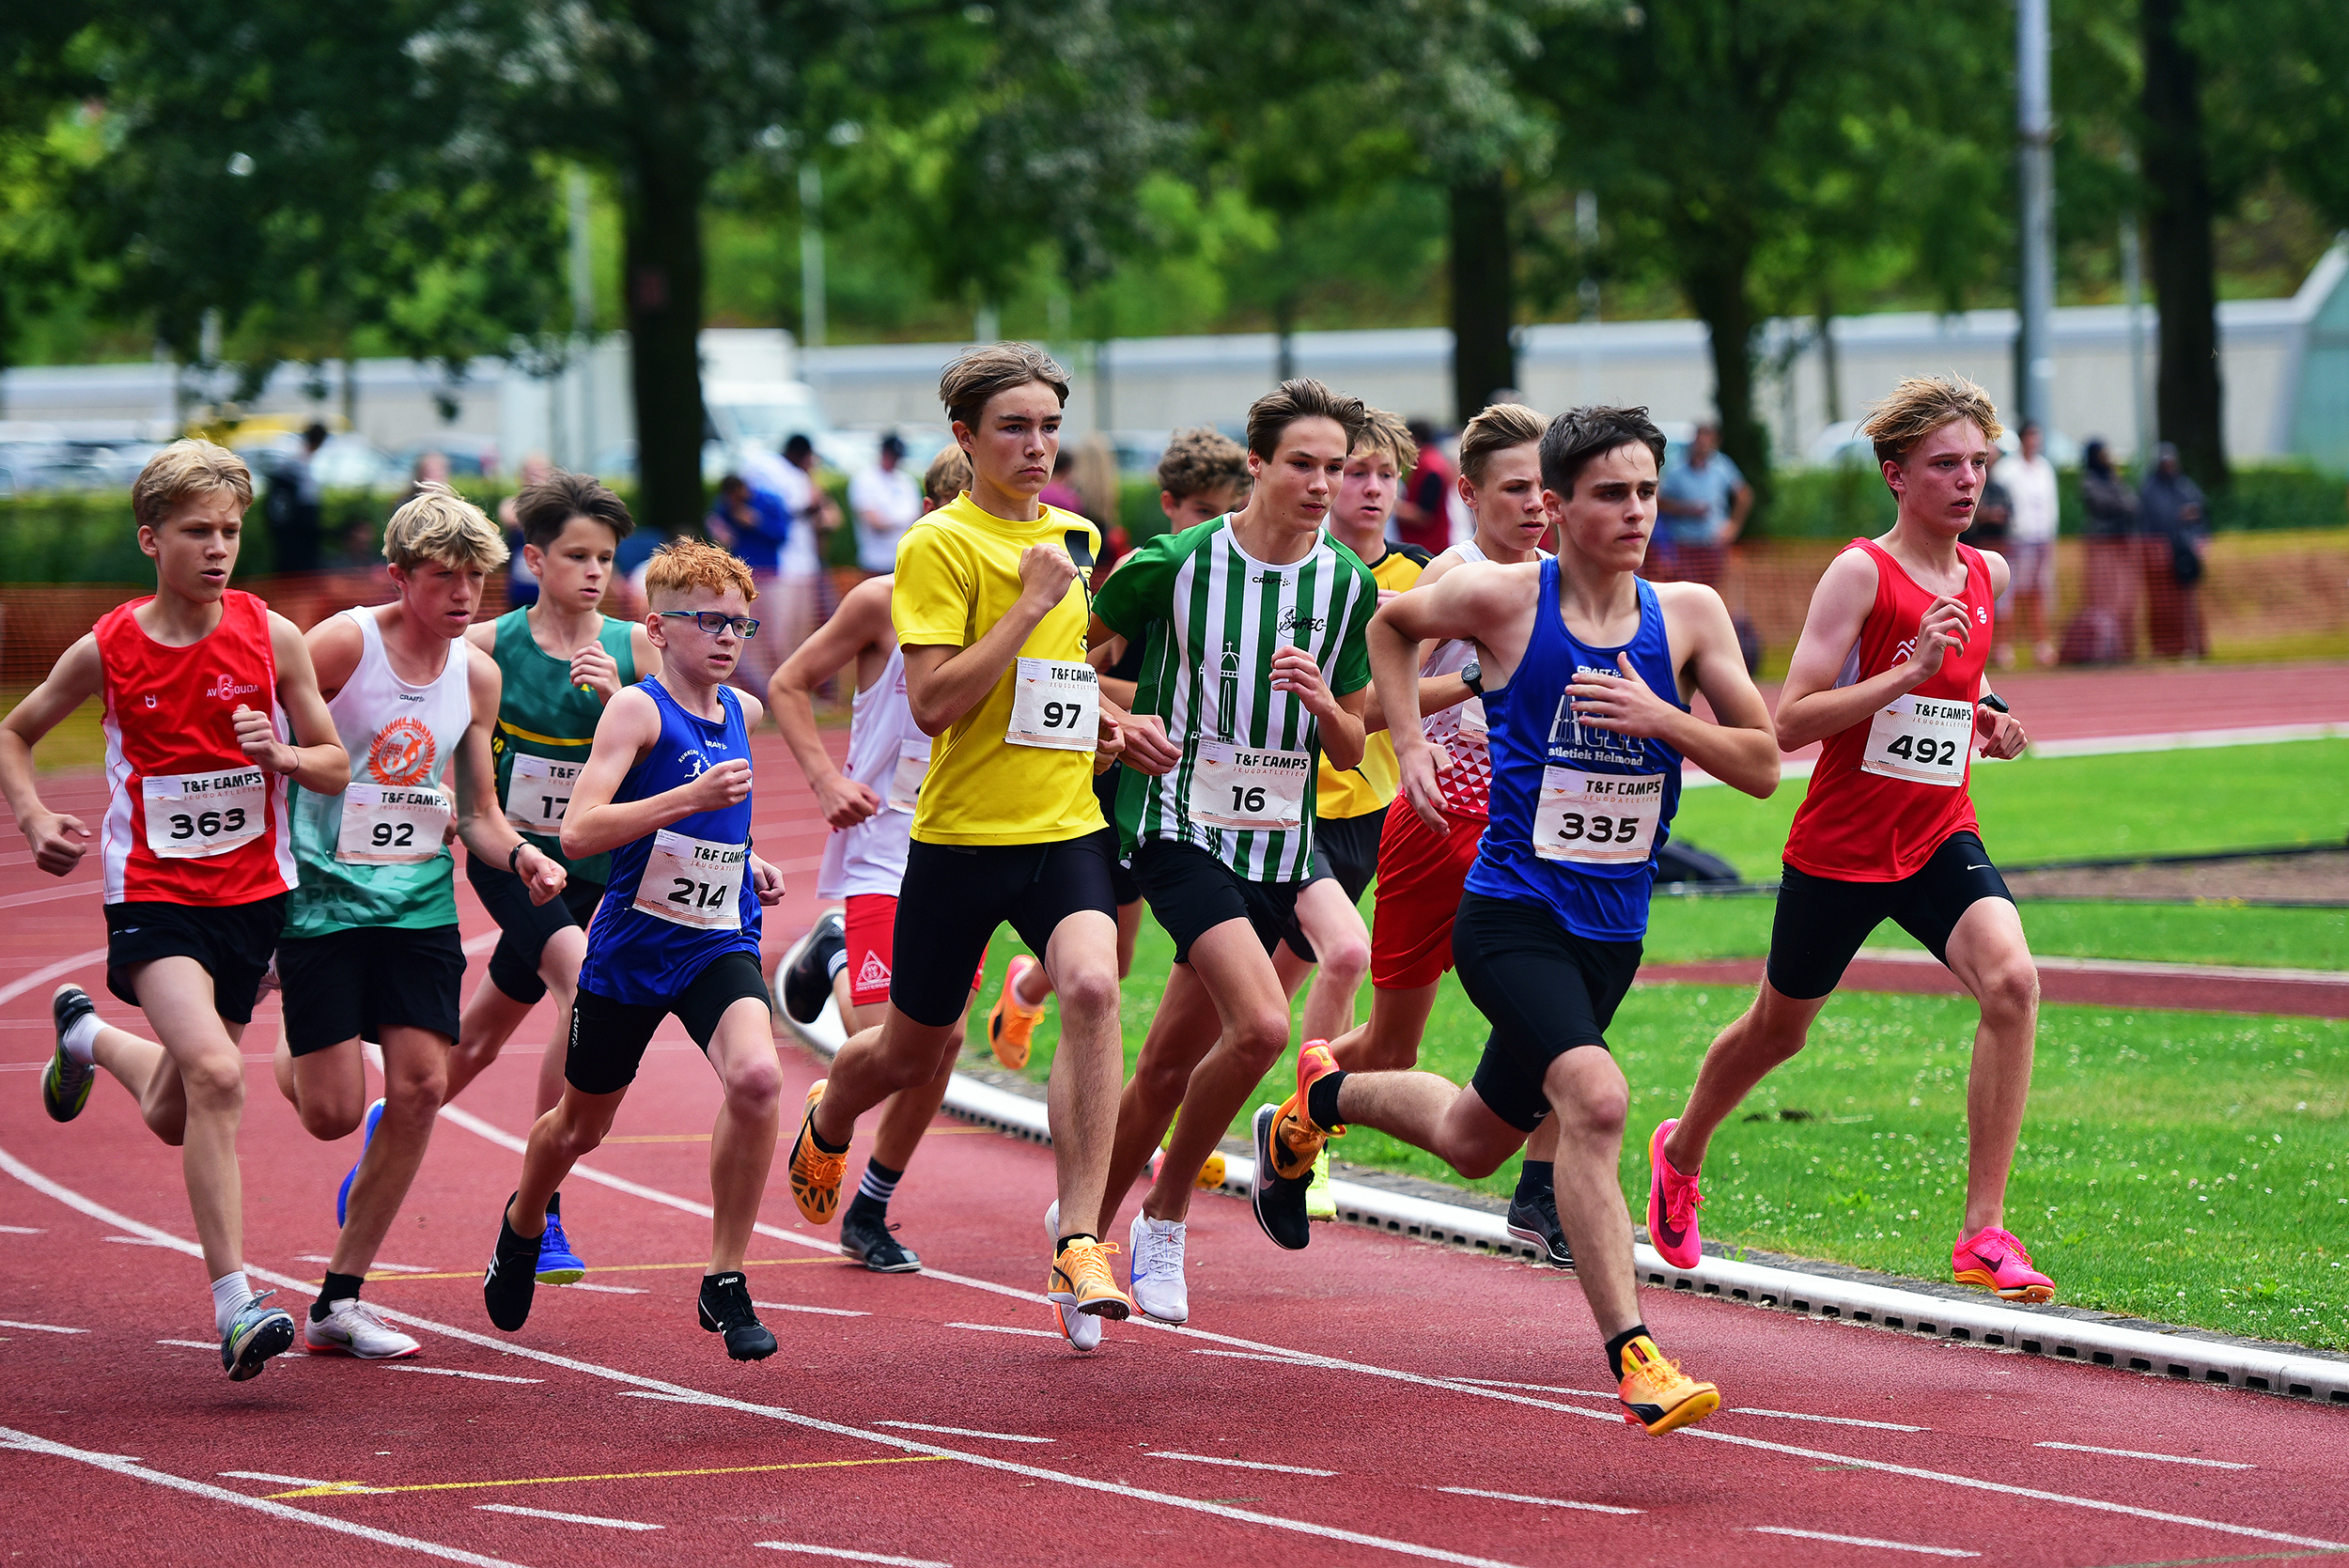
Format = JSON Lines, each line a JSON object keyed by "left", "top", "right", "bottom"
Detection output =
{"left": 1093, "top": 517, "right": 1379, "bottom": 882}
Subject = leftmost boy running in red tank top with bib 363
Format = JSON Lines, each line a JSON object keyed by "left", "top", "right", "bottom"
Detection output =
{"left": 0, "top": 442, "right": 350, "bottom": 1383}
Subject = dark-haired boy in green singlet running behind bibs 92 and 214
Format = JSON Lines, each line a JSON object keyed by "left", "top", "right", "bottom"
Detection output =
{"left": 449, "top": 472, "right": 661, "bottom": 1284}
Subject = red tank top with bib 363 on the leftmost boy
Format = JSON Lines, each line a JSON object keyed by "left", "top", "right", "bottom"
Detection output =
{"left": 94, "top": 589, "right": 296, "bottom": 908}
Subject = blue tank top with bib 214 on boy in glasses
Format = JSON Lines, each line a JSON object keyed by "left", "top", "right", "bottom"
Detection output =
{"left": 581, "top": 676, "right": 759, "bottom": 1007}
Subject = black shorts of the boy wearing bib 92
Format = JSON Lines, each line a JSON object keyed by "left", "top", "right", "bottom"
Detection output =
{"left": 277, "top": 924, "right": 465, "bottom": 1056}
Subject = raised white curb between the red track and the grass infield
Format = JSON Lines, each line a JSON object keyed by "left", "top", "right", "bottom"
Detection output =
{"left": 775, "top": 946, "right": 2349, "bottom": 1406}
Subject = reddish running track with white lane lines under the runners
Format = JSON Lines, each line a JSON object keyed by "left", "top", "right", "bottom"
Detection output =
{"left": 0, "top": 672, "right": 2349, "bottom": 1566}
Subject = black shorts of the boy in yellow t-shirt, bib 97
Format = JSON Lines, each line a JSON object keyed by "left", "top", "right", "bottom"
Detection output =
{"left": 888, "top": 829, "right": 1118, "bottom": 1028}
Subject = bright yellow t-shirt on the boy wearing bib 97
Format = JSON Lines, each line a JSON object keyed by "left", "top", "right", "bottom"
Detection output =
{"left": 891, "top": 490, "right": 1104, "bottom": 845}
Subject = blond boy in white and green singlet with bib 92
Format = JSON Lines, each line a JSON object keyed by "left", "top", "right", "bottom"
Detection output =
{"left": 272, "top": 484, "right": 564, "bottom": 1361}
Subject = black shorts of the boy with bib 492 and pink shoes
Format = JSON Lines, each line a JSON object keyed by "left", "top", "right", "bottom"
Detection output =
{"left": 1769, "top": 831, "right": 2015, "bottom": 1000}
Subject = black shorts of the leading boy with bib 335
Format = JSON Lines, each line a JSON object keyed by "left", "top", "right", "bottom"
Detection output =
{"left": 1452, "top": 892, "right": 1640, "bottom": 1131}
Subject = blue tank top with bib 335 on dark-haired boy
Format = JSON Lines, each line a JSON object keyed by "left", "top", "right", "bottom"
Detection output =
{"left": 1469, "top": 561, "right": 1689, "bottom": 941}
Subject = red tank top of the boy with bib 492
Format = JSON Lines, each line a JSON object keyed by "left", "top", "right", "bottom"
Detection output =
{"left": 1785, "top": 540, "right": 1992, "bottom": 882}
